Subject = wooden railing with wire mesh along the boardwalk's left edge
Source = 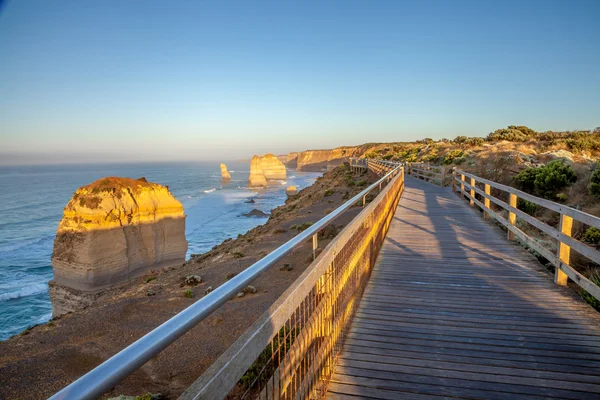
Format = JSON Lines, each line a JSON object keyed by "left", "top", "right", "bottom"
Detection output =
{"left": 180, "top": 161, "right": 404, "bottom": 400}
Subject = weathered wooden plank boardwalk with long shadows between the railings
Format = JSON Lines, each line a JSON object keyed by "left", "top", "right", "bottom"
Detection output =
{"left": 327, "top": 177, "right": 600, "bottom": 400}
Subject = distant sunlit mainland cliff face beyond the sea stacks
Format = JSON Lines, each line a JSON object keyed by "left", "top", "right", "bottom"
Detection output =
{"left": 279, "top": 146, "right": 363, "bottom": 171}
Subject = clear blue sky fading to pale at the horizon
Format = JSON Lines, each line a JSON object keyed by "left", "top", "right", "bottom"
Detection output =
{"left": 0, "top": 0, "right": 600, "bottom": 161}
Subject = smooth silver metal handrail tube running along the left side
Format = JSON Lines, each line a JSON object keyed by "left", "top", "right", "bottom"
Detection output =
{"left": 49, "top": 160, "right": 402, "bottom": 400}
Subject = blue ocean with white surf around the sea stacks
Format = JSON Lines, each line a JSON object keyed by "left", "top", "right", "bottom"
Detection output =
{"left": 0, "top": 162, "right": 320, "bottom": 340}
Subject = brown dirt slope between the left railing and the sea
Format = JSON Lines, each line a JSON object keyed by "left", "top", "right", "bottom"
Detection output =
{"left": 0, "top": 165, "right": 377, "bottom": 399}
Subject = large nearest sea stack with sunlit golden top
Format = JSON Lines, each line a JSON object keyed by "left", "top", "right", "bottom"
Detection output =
{"left": 50, "top": 177, "right": 188, "bottom": 316}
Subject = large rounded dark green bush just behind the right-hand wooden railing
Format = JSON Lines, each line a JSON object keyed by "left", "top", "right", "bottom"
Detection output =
{"left": 514, "top": 160, "right": 577, "bottom": 200}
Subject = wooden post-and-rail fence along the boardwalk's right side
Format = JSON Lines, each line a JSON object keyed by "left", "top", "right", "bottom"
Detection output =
{"left": 452, "top": 169, "right": 600, "bottom": 300}
